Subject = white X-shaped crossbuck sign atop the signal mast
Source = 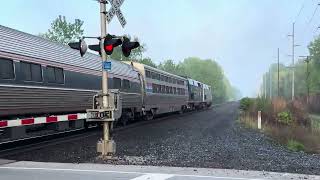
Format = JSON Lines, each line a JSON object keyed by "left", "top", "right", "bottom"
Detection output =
{"left": 106, "top": 0, "right": 127, "bottom": 28}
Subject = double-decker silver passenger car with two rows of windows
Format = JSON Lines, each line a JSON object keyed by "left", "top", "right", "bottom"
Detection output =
{"left": 127, "top": 62, "right": 188, "bottom": 117}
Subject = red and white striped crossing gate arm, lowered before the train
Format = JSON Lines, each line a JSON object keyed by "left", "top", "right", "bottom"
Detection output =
{"left": 0, "top": 113, "right": 87, "bottom": 128}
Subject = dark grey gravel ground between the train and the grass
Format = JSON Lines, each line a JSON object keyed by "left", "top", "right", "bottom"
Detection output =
{"left": 2, "top": 103, "right": 320, "bottom": 175}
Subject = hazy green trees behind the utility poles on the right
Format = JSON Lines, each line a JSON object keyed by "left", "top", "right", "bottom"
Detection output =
{"left": 260, "top": 37, "right": 320, "bottom": 99}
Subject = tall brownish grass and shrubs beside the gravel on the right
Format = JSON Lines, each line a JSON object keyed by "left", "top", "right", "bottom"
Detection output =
{"left": 239, "top": 98, "right": 320, "bottom": 153}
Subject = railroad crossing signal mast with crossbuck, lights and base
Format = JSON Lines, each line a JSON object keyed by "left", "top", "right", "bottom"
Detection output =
{"left": 68, "top": 0, "right": 140, "bottom": 158}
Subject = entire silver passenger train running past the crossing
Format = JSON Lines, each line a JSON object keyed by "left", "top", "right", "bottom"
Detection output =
{"left": 0, "top": 25, "right": 212, "bottom": 128}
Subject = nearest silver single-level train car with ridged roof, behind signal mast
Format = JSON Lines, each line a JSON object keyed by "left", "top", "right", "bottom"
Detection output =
{"left": 0, "top": 26, "right": 142, "bottom": 119}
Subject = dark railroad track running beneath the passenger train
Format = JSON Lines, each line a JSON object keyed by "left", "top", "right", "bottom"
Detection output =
{"left": 0, "top": 108, "right": 211, "bottom": 158}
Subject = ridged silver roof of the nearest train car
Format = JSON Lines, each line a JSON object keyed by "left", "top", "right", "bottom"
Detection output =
{"left": 0, "top": 25, "right": 137, "bottom": 76}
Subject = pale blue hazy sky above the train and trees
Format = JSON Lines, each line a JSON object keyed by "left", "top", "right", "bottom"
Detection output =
{"left": 0, "top": 0, "right": 320, "bottom": 96}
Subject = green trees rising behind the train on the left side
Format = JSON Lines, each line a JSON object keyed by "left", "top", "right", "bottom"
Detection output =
{"left": 40, "top": 16, "right": 241, "bottom": 103}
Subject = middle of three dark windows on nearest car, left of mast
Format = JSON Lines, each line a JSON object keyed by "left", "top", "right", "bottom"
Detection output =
{"left": 20, "top": 62, "right": 42, "bottom": 82}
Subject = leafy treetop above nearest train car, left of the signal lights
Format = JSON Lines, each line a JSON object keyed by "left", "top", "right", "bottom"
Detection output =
{"left": 40, "top": 15, "right": 84, "bottom": 44}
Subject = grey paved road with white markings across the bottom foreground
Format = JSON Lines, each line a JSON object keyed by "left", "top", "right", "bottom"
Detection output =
{"left": 0, "top": 161, "right": 320, "bottom": 180}
